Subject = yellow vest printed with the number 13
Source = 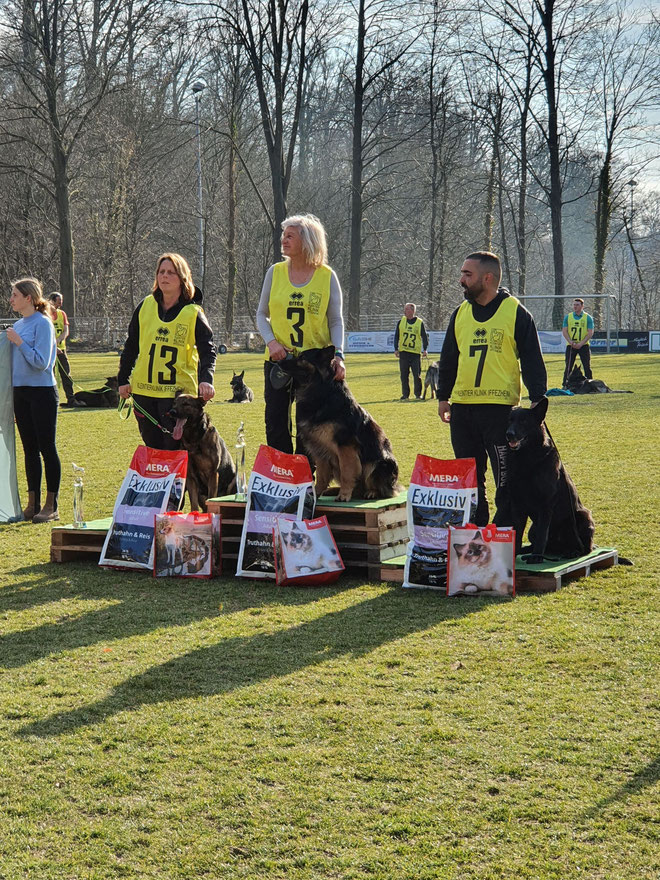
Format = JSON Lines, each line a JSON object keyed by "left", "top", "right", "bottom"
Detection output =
{"left": 131, "top": 296, "right": 202, "bottom": 397}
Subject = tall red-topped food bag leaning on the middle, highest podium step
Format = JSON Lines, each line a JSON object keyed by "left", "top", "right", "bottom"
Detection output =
{"left": 236, "top": 446, "right": 316, "bottom": 580}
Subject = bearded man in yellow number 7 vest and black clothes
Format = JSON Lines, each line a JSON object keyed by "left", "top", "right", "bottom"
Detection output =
{"left": 438, "top": 251, "right": 547, "bottom": 526}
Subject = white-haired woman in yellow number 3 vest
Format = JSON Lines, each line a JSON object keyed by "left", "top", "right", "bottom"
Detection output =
{"left": 257, "top": 214, "right": 346, "bottom": 453}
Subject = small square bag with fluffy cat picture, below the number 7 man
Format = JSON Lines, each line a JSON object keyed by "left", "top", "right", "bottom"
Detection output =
{"left": 447, "top": 525, "right": 516, "bottom": 596}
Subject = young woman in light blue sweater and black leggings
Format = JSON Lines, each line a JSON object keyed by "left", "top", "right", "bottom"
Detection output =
{"left": 7, "top": 278, "right": 62, "bottom": 522}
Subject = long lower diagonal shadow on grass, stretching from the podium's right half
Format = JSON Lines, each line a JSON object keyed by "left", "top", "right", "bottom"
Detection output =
{"left": 17, "top": 590, "right": 489, "bottom": 737}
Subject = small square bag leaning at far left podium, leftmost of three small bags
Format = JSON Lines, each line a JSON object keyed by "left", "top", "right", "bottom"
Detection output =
{"left": 153, "top": 511, "right": 221, "bottom": 578}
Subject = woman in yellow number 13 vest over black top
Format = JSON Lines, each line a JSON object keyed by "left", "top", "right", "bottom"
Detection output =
{"left": 118, "top": 253, "right": 216, "bottom": 449}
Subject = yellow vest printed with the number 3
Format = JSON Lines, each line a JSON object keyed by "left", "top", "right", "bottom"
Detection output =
{"left": 266, "top": 261, "right": 332, "bottom": 360}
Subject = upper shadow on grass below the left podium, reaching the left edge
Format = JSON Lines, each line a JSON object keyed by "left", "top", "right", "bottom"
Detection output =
{"left": 0, "top": 564, "right": 352, "bottom": 669}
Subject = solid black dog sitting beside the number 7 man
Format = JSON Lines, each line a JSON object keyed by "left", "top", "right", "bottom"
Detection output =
{"left": 506, "top": 398, "right": 594, "bottom": 563}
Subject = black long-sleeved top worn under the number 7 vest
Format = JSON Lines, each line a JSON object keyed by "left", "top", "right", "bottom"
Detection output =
{"left": 438, "top": 287, "right": 548, "bottom": 403}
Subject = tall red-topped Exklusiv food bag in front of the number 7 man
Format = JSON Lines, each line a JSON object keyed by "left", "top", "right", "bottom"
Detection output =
{"left": 403, "top": 455, "right": 477, "bottom": 591}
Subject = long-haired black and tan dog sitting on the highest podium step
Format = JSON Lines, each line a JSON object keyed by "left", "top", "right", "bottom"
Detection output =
{"left": 279, "top": 345, "right": 400, "bottom": 501}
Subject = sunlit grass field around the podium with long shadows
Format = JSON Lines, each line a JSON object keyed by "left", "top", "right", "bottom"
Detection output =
{"left": 0, "top": 354, "right": 660, "bottom": 880}
